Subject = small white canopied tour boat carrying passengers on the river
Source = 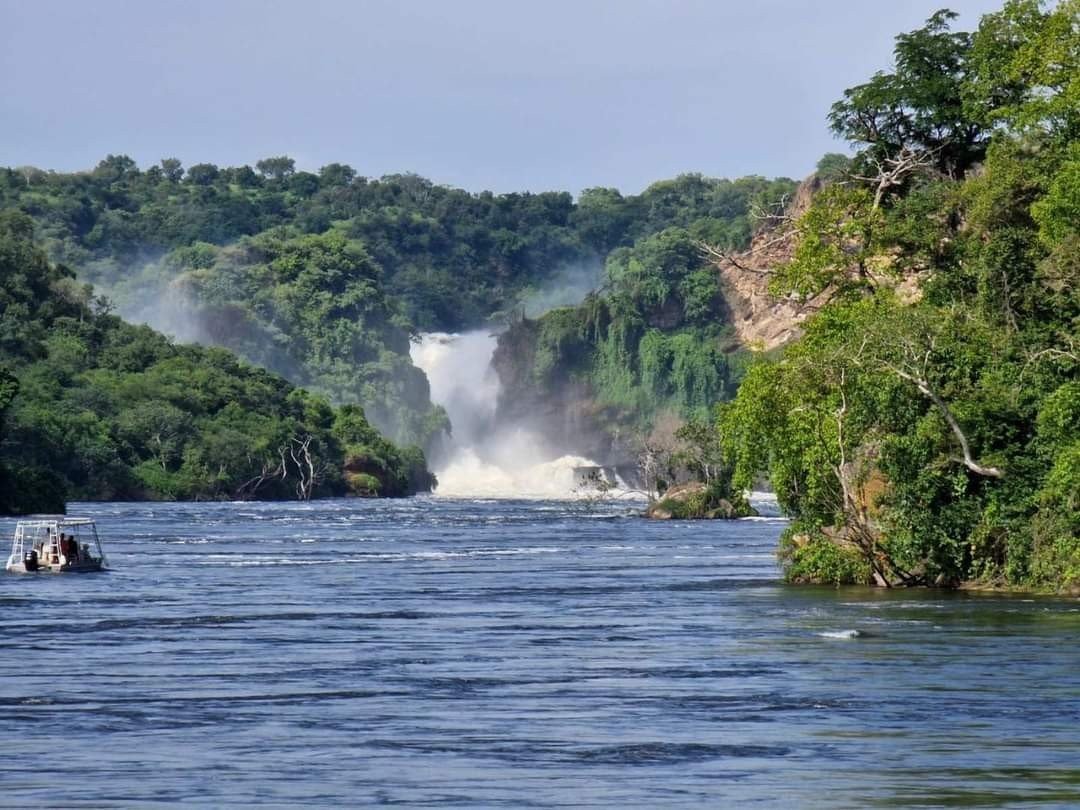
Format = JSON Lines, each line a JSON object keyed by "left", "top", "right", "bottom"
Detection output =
{"left": 6, "top": 517, "right": 108, "bottom": 573}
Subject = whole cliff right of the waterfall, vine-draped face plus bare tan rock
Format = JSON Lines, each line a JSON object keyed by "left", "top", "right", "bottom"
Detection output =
{"left": 492, "top": 177, "right": 821, "bottom": 467}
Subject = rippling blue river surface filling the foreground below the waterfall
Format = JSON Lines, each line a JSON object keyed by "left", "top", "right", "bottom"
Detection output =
{"left": 0, "top": 499, "right": 1080, "bottom": 808}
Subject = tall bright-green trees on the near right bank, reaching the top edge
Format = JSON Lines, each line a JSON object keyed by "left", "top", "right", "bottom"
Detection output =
{"left": 718, "top": 0, "right": 1080, "bottom": 586}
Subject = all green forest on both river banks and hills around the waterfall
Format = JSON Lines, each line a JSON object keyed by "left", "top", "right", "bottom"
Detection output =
{"left": 0, "top": 0, "right": 1080, "bottom": 593}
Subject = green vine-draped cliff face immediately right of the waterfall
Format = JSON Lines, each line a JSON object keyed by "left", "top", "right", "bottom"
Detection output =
{"left": 495, "top": 228, "right": 745, "bottom": 464}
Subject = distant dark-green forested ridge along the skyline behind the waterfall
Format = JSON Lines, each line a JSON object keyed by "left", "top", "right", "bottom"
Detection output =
{"left": 0, "top": 156, "right": 793, "bottom": 332}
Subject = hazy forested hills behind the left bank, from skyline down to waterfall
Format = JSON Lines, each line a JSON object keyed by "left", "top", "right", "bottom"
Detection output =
{"left": 0, "top": 156, "right": 793, "bottom": 447}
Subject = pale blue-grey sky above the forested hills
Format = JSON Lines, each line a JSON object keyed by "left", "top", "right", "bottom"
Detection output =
{"left": 0, "top": 0, "right": 1001, "bottom": 193}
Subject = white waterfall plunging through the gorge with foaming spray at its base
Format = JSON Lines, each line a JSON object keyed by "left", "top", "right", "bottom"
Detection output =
{"left": 411, "top": 332, "right": 622, "bottom": 498}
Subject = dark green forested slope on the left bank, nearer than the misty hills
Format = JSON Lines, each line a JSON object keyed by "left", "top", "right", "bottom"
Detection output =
{"left": 0, "top": 211, "right": 432, "bottom": 513}
